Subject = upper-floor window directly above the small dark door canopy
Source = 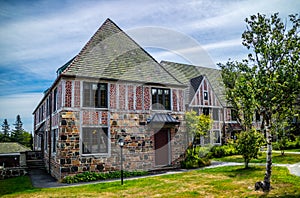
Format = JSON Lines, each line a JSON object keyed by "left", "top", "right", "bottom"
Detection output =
{"left": 151, "top": 88, "right": 171, "bottom": 110}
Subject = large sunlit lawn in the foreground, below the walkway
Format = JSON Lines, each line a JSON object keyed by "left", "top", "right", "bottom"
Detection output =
{"left": 2, "top": 166, "right": 300, "bottom": 198}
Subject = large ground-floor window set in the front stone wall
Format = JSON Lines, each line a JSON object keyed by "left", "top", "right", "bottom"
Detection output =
{"left": 82, "top": 127, "right": 108, "bottom": 154}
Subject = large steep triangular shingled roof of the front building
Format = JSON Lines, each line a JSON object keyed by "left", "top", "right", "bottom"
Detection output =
{"left": 60, "top": 19, "right": 182, "bottom": 86}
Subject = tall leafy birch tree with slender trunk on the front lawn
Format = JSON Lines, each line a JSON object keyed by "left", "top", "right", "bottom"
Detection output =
{"left": 220, "top": 13, "right": 300, "bottom": 191}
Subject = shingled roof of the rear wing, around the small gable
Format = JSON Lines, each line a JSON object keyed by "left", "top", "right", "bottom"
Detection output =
{"left": 160, "top": 61, "right": 226, "bottom": 106}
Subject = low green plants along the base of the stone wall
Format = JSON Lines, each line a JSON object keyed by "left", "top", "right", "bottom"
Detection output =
{"left": 61, "top": 171, "right": 148, "bottom": 184}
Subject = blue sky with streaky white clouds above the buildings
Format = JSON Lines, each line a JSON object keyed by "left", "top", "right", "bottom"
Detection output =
{"left": 0, "top": 0, "right": 300, "bottom": 132}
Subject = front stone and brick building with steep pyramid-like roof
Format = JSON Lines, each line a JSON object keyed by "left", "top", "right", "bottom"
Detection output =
{"left": 33, "top": 19, "right": 188, "bottom": 179}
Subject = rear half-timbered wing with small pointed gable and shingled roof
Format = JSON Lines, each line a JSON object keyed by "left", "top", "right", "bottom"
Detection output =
{"left": 161, "top": 61, "right": 232, "bottom": 144}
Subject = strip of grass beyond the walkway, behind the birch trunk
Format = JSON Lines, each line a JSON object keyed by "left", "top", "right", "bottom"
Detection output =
{"left": 213, "top": 152, "right": 300, "bottom": 164}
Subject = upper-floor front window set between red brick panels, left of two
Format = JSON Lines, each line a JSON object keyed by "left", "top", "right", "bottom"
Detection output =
{"left": 83, "top": 82, "right": 107, "bottom": 108}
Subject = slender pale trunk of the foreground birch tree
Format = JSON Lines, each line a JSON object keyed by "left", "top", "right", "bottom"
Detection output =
{"left": 263, "top": 126, "right": 272, "bottom": 191}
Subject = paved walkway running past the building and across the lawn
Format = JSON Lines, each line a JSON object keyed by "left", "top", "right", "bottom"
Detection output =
{"left": 29, "top": 152, "right": 300, "bottom": 188}
